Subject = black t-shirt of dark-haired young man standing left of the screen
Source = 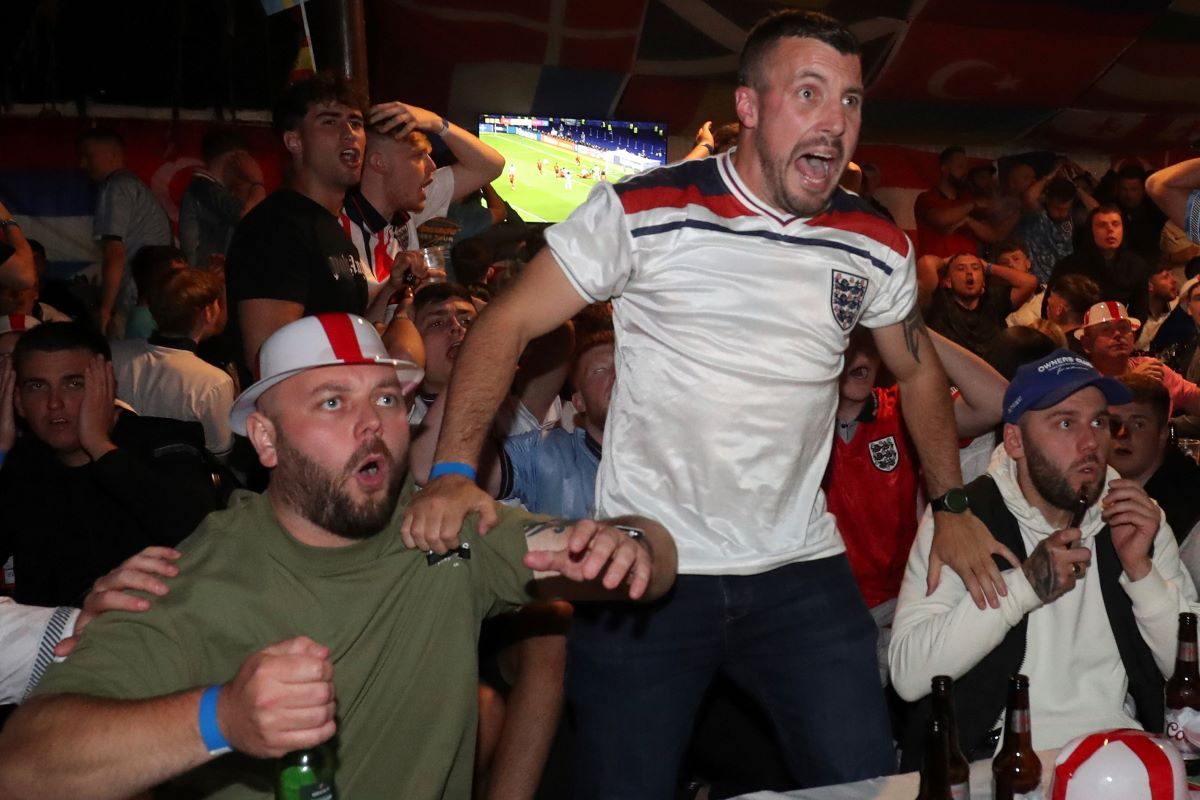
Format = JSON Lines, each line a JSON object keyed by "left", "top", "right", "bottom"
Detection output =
{"left": 226, "top": 190, "right": 367, "bottom": 376}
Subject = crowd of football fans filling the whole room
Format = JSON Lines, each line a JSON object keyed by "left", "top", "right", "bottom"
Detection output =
{"left": 0, "top": 12, "right": 1200, "bottom": 798}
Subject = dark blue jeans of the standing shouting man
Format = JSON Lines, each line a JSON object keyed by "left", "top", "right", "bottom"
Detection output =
{"left": 566, "top": 555, "right": 895, "bottom": 800}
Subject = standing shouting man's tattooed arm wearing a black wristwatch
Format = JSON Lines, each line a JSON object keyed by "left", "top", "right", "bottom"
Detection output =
{"left": 872, "top": 308, "right": 1018, "bottom": 608}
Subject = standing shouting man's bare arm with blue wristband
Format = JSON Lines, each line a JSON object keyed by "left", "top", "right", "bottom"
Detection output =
{"left": 401, "top": 248, "right": 587, "bottom": 553}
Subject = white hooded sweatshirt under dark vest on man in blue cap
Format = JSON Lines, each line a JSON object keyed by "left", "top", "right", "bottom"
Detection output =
{"left": 888, "top": 445, "right": 1198, "bottom": 750}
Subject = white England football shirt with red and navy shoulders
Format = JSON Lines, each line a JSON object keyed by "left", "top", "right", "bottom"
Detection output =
{"left": 546, "top": 155, "right": 916, "bottom": 575}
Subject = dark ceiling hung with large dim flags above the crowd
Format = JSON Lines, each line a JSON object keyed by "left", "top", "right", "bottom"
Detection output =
{"left": 0, "top": 0, "right": 1200, "bottom": 152}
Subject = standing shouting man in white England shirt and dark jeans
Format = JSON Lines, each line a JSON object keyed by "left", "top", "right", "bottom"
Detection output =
{"left": 403, "top": 10, "right": 1010, "bottom": 798}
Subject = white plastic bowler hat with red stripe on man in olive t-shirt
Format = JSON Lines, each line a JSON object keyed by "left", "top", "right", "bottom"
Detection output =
{"left": 229, "top": 314, "right": 425, "bottom": 435}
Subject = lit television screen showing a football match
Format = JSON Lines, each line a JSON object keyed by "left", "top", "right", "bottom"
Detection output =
{"left": 479, "top": 114, "right": 667, "bottom": 222}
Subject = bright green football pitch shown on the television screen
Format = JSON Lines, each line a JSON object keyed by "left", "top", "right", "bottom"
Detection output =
{"left": 480, "top": 133, "right": 629, "bottom": 222}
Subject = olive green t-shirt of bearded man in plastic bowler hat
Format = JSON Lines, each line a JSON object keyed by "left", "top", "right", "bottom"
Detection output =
{"left": 37, "top": 493, "right": 534, "bottom": 800}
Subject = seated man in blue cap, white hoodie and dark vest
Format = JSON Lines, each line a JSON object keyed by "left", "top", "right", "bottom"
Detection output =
{"left": 889, "top": 349, "right": 1196, "bottom": 768}
